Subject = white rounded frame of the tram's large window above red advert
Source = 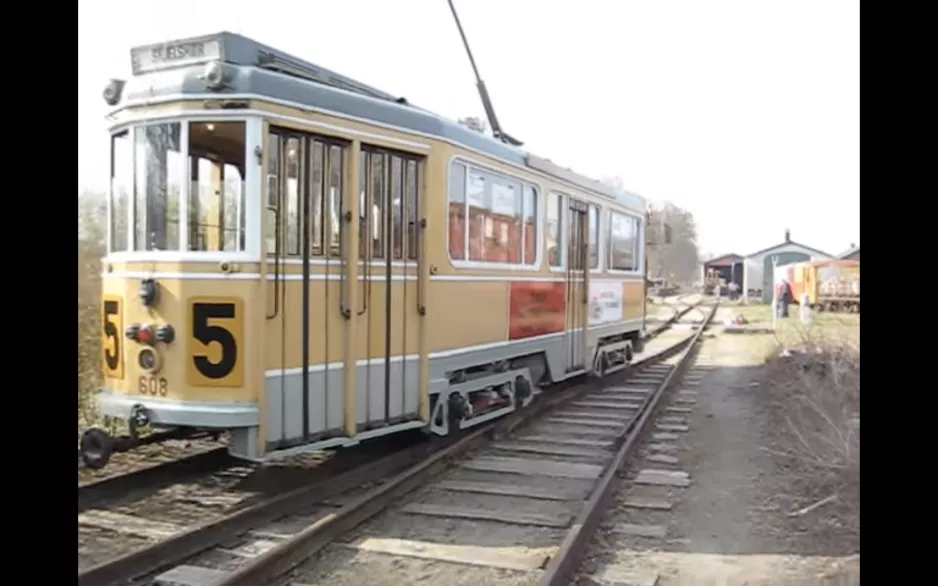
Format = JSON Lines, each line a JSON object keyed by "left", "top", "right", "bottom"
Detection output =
{"left": 444, "top": 155, "right": 545, "bottom": 272}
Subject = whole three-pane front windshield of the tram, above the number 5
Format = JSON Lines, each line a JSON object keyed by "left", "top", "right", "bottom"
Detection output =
{"left": 110, "top": 121, "right": 245, "bottom": 252}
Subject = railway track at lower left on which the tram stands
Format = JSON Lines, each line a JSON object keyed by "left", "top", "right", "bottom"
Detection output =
{"left": 78, "top": 432, "right": 437, "bottom": 585}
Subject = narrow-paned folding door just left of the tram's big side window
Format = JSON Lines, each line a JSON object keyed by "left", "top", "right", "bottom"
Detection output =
{"left": 353, "top": 145, "right": 425, "bottom": 431}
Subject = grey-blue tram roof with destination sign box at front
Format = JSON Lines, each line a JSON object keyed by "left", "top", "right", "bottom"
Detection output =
{"left": 124, "top": 31, "right": 645, "bottom": 210}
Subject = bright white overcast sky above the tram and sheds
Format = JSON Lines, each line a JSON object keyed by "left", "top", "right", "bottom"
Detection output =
{"left": 78, "top": 0, "right": 860, "bottom": 254}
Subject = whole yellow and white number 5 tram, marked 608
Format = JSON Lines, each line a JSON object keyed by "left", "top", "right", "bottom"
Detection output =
{"left": 82, "top": 33, "right": 646, "bottom": 466}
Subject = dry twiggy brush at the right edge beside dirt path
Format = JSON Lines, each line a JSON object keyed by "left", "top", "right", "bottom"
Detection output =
{"left": 762, "top": 326, "right": 860, "bottom": 527}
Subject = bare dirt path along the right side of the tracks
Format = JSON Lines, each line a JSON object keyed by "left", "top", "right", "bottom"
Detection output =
{"left": 579, "top": 309, "right": 860, "bottom": 586}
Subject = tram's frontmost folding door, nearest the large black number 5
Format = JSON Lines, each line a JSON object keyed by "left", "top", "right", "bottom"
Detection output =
{"left": 267, "top": 128, "right": 346, "bottom": 447}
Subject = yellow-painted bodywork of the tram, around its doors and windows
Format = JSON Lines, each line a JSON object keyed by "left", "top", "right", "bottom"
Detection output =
{"left": 102, "top": 101, "right": 644, "bottom": 453}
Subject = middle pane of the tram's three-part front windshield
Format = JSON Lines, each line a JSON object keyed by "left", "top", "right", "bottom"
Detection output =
{"left": 134, "top": 122, "right": 185, "bottom": 250}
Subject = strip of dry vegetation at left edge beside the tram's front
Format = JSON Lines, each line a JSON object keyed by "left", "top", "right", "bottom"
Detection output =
{"left": 78, "top": 241, "right": 102, "bottom": 432}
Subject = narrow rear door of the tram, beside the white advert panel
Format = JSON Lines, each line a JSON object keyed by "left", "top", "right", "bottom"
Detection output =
{"left": 564, "top": 198, "right": 589, "bottom": 372}
